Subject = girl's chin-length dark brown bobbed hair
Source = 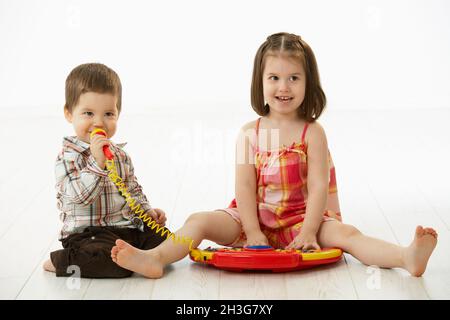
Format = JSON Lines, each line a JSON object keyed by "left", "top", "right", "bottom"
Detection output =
{"left": 251, "top": 32, "right": 326, "bottom": 122}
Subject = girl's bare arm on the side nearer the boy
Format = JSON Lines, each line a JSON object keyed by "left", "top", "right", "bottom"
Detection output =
{"left": 235, "top": 123, "right": 267, "bottom": 244}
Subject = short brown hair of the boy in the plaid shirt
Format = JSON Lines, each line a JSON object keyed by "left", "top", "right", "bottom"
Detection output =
{"left": 64, "top": 63, "right": 122, "bottom": 113}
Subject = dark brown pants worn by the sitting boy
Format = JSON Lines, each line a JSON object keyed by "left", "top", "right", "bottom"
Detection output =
{"left": 50, "top": 226, "right": 166, "bottom": 278}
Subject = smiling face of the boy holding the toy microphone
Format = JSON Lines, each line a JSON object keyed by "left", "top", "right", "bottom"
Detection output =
{"left": 64, "top": 92, "right": 119, "bottom": 143}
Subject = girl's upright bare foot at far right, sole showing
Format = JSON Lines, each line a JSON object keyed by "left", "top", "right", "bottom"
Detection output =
{"left": 404, "top": 226, "right": 437, "bottom": 277}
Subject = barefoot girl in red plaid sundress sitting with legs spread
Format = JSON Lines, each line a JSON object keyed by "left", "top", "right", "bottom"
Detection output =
{"left": 111, "top": 33, "right": 437, "bottom": 278}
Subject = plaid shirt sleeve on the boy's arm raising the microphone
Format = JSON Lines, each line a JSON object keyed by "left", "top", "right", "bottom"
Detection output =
{"left": 55, "top": 151, "right": 108, "bottom": 205}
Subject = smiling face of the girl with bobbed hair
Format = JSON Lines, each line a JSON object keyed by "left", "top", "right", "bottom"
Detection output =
{"left": 263, "top": 55, "right": 306, "bottom": 116}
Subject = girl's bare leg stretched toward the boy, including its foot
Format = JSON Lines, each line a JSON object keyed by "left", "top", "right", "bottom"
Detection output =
{"left": 111, "top": 211, "right": 241, "bottom": 278}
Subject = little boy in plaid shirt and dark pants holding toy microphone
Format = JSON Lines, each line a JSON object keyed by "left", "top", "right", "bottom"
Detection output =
{"left": 44, "top": 63, "right": 166, "bottom": 278}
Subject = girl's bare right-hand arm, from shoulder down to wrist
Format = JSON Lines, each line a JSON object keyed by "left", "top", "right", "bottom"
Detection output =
{"left": 302, "top": 122, "right": 330, "bottom": 236}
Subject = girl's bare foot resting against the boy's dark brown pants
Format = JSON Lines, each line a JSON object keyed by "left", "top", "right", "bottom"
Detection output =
{"left": 111, "top": 239, "right": 164, "bottom": 279}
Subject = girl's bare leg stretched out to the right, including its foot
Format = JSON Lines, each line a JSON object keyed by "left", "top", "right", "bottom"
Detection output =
{"left": 317, "top": 221, "right": 437, "bottom": 277}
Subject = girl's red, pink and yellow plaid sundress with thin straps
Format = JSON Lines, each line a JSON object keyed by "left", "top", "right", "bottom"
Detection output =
{"left": 220, "top": 118, "right": 342, "bottom": 248}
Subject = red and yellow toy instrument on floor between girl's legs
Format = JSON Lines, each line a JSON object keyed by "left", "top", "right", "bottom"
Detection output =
{"left": 189, "top": 246, "right": 342, "bottom": 272}
